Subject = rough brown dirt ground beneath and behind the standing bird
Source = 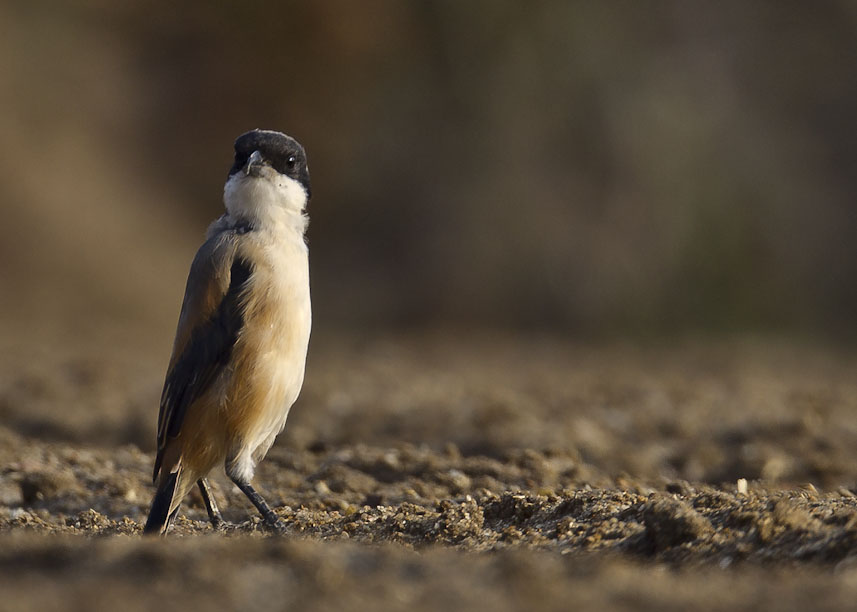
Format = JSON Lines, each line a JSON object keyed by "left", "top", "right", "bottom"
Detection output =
{"left": 0, "top": 333, "right": 857, "bottom": 611}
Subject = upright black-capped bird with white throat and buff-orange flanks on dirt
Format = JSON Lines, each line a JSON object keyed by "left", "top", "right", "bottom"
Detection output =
{"left": 143, "top": 129, "right": 312, "bottom": 535}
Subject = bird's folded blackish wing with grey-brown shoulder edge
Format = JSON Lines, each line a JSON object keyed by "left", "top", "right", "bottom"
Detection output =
{"left": 154, "top": 232, "right": 251, "bottom": 478}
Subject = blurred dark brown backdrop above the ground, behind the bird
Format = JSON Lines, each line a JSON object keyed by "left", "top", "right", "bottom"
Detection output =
{"left": 0, "top": 0, "right": 857, "bottom": 354}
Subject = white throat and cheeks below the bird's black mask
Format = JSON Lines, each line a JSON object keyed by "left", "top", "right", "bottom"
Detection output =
{"left": 223, "top": 168, "right": 308, "bottom": 236}
